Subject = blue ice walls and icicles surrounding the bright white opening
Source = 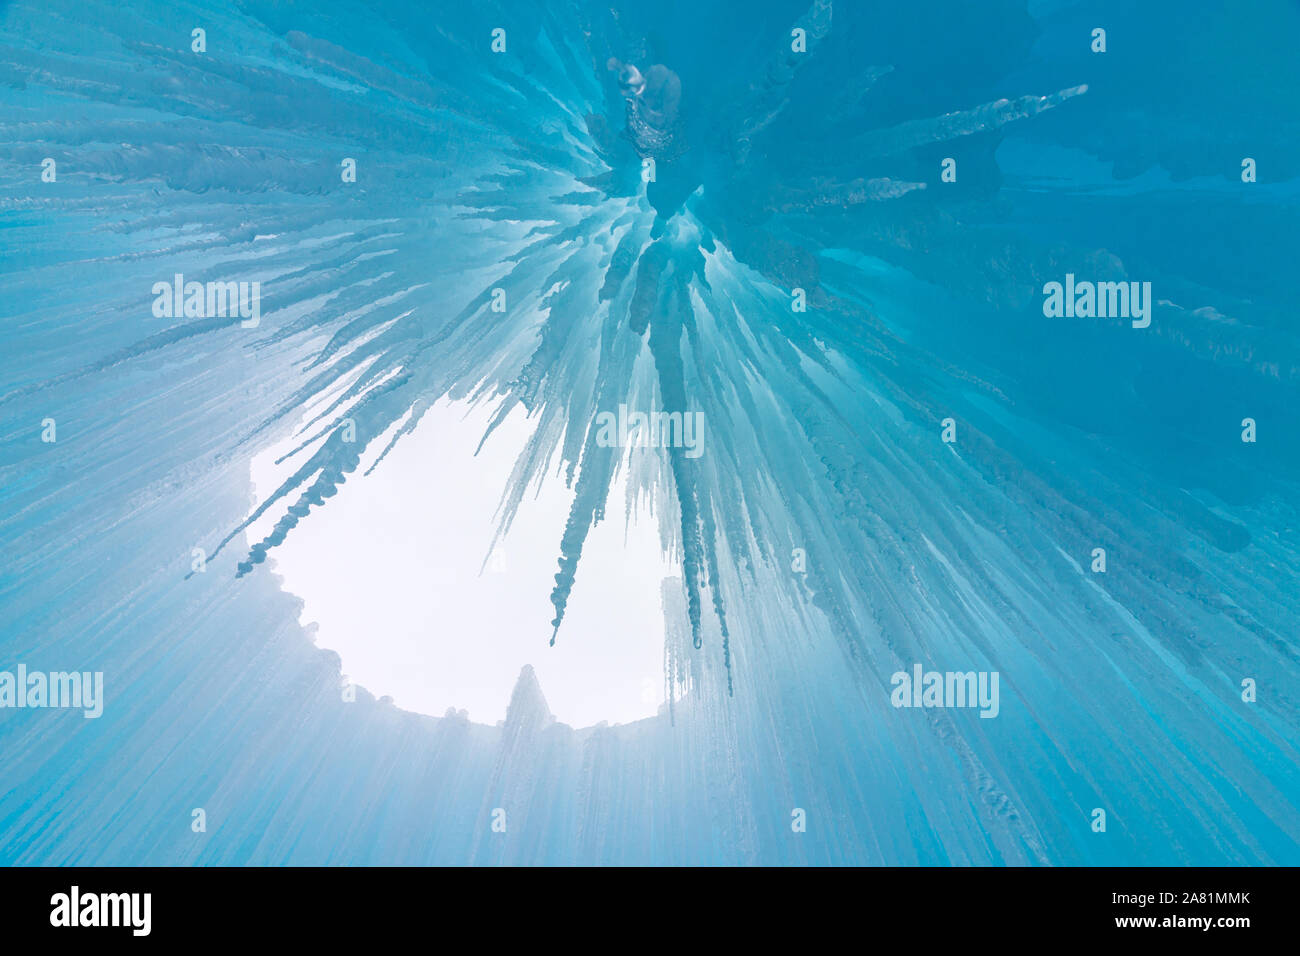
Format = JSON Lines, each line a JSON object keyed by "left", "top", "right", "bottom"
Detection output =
{"left": 0, "top": 0, "right": 1300, "bottom": 864}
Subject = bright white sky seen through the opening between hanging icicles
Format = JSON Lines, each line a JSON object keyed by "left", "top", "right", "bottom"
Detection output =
{"left": 250, "top": 392, "right": 673, "bottom": 727}
